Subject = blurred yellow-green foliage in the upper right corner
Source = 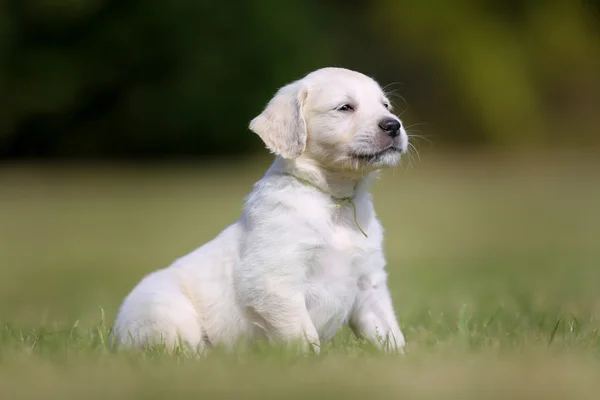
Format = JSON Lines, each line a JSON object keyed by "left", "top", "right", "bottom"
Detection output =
{"left": 374, "top": 0, "right": 600, "bottom": 146}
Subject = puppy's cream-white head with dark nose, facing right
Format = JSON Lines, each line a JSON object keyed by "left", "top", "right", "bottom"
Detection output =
{"left": 250, "top": 68, "right": 408, "bottom": 170}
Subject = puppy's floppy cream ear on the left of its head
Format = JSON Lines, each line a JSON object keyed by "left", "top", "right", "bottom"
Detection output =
{"left": 250, "top": 81, "right": 307, "bottom": 159}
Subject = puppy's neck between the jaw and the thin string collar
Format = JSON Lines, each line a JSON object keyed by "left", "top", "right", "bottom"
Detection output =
{"left": 267, "top": 157, "right": 375, "bottom": 198}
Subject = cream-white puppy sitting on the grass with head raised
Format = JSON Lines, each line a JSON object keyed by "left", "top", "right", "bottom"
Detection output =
{"left": 110, "top": 68, "right": 408, "bottom": 352}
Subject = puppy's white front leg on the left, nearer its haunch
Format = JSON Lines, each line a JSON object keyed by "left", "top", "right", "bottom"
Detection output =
{"left": 239, "top": 228, "right": 320, "bottom": 352}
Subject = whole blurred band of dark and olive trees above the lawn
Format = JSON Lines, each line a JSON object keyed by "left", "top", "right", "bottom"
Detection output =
{"left": 0, "top": 0, "right": 600, "bottom": 159}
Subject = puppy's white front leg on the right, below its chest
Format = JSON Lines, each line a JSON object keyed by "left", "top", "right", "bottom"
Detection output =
{"left": 350, "top": 270, "right": 405, "bottom": 353}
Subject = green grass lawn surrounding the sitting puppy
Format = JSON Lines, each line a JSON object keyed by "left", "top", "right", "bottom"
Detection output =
{"left": 0, "top": 153, "right": 600, "bottom": 399}
